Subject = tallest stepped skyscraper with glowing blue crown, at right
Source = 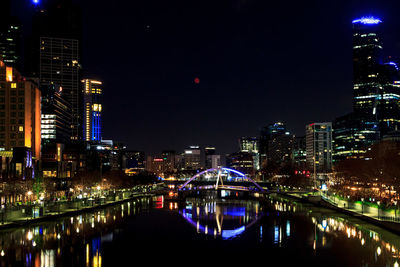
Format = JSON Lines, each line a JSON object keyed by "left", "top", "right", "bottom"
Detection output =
{"left": 352, "top": 17, "right": 400, "bottom": 138}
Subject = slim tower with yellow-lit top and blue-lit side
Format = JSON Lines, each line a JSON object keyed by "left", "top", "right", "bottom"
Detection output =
{"left": 82, "top": 79, "right": 103, "bottom": 142}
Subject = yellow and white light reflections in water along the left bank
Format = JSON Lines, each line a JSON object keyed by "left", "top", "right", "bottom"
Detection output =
{"left": 0, "top": 198, "right": 150, "bottom": 266}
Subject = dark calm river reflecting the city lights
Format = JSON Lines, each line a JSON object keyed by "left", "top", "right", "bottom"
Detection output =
{"left": 0, "top": 196, "right": 400, "bottom": 266}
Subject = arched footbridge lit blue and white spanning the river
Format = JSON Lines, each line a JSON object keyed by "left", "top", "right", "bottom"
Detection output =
{"left": 179, "top": 168, "right": 264, "bottom": 191}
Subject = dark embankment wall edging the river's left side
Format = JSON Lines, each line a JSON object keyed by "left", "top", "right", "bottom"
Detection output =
{"left": 0, "top": 193, "right": 154, "bottom": 230}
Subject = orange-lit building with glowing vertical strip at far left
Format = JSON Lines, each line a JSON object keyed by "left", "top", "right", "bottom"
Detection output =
{"left": 0, "top": 61, "right": 41, "bottom": 159}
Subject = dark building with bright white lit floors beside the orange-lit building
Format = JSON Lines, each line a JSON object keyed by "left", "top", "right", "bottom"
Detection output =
{"left": 42, "top": 84, "right": 71, "bottom": 145}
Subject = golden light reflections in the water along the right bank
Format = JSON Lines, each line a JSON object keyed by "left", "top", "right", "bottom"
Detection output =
{"left": 267, "top": 199, "right": 400, "bottom": 266}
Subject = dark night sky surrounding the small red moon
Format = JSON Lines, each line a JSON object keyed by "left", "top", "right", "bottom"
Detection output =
{"left": 16, "top": 0, "right": 400, "bottom": 156}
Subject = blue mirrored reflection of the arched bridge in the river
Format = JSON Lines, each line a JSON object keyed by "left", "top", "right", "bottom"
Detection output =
{"left": 179, "top": 199, "right": 261, "bottom": 240}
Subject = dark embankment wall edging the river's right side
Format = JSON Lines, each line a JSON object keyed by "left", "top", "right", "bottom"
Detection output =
{"left": 277, "top": 192, "right": 400, "bottom": 235}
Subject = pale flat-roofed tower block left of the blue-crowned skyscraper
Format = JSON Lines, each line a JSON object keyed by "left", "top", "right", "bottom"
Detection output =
{"left": 306, "top": 122, "right": 332, "bottom": 172}
